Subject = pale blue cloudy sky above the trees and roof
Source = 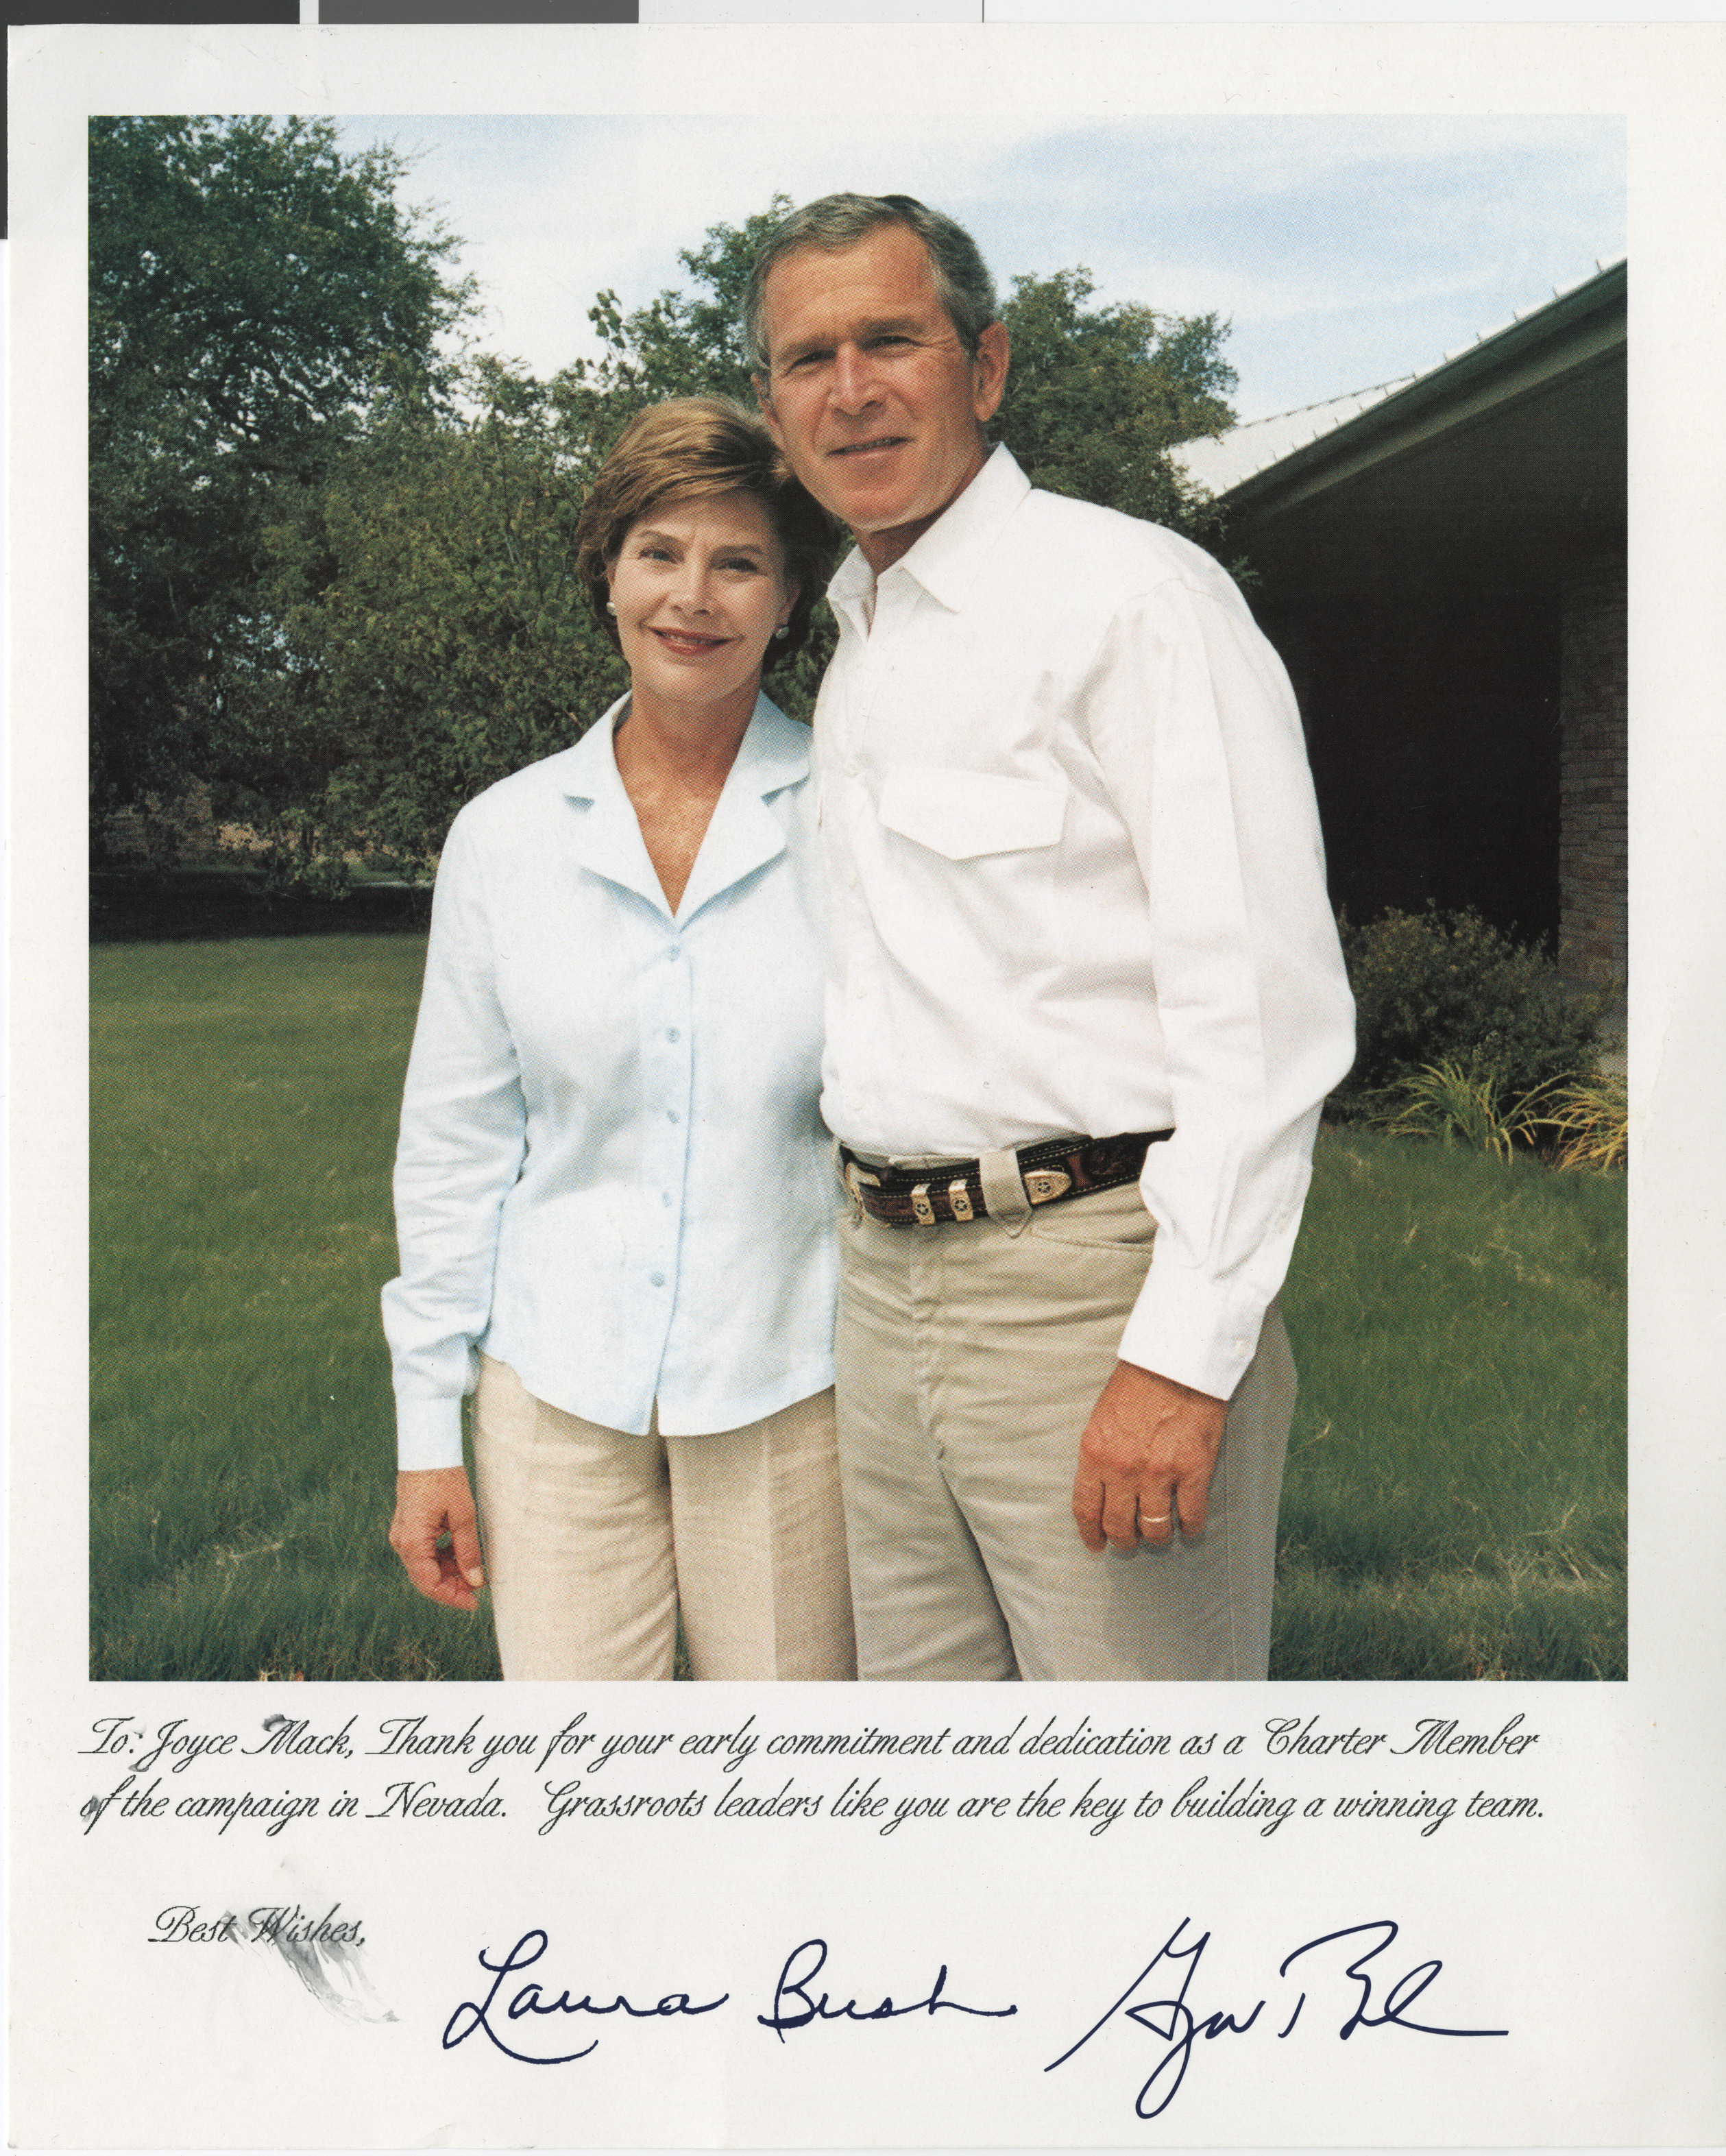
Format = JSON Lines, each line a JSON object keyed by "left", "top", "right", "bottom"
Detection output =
{"left": 341, "top": 114, "right": 1625, "bottom": 418}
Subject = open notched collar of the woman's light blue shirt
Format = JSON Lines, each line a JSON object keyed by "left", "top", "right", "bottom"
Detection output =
{"left": 558, "top": 697, "right": 810, "bottom": 925}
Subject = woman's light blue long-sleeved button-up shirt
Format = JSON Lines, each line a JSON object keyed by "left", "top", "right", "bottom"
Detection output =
{"left": 384, "top": 697, "right": 836, "bottom": 1468}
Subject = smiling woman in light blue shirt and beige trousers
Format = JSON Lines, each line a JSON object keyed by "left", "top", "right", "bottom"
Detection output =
{"left": 384, "top": 397, "right": 855, "bottom": 1677}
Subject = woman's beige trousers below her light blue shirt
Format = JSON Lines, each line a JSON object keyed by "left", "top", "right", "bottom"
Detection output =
{"left": 474, "top": 1356, "right": 858, "bottom": 1680}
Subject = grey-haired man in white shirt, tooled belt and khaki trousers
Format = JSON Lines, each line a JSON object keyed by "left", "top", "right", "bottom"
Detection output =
{"left": 746, "top": 196, "right": 1353, "bottom": 1677}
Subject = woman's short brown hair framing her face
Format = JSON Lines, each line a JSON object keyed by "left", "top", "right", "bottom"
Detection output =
{"left": 575, "top": 397, "right": 838, "bottom": 666}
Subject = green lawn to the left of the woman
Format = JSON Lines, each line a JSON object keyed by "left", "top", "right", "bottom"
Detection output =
{"left": 90, "top": 936, "right": 498, "bottom": 1680}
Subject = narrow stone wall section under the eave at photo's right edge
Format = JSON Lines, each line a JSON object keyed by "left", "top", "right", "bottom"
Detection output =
{"left": 1558, "top": 559, "right": 1629, "bottom": 987}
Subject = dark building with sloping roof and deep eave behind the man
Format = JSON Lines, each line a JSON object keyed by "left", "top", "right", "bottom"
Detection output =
{"left": 1179, "top": 261, "right": 1627, "bottom": 985}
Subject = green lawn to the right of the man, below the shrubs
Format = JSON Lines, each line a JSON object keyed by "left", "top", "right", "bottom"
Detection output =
{"left": 1272, "top": 1128, "right": 1627, "bottom": 1677}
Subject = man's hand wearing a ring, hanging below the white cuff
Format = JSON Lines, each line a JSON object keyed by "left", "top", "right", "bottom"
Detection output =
{"left": 1073, "top": 1363, "right": 1228, "bottom": 1555}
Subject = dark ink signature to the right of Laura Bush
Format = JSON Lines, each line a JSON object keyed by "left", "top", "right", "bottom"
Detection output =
{"left": 1043, "top": 1917, "right": 1511, "bottom": 2120}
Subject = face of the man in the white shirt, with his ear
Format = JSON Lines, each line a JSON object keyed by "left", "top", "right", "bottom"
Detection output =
{"left": 756, "top": 224, "right": 1006, "bottom": 571}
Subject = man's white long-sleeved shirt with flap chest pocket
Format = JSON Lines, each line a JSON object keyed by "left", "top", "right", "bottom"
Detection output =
{"left": 814, "top": 448, "right": 1353, "bottom": 1397}
